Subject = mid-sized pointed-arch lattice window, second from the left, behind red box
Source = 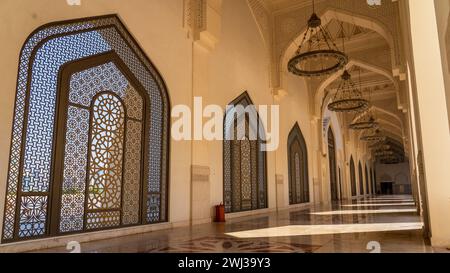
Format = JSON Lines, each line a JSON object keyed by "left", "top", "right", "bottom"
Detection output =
{"left": 223, "top": 92, "right": 267, "bottom": 213}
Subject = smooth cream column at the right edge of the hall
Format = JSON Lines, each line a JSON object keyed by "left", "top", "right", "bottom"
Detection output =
{"left": 408, "top": 0, "right": 450, "bottom": 246}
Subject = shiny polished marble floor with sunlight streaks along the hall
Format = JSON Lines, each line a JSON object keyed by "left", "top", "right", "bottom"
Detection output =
{"left": 33, "top": 196, "right": 446, "bottom": 253}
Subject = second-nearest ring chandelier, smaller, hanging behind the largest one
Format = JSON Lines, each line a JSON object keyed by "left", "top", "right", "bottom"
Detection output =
{"left": 328, "top": 70, "right": 369, "bottom": 112}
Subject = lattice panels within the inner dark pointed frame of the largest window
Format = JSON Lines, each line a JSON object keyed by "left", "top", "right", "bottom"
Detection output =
{"left": 59, "top": 62, "right": 144, "bottom": 233}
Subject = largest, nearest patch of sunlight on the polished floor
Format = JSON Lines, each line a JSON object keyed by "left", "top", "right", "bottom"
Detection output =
{"left": 226, "top": 222, "right": 423, "bottom": 238}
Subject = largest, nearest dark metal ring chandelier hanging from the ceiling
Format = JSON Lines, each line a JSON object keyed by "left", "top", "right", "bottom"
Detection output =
{"left": 288, "top": 0, "right": 348, "bottom": 77}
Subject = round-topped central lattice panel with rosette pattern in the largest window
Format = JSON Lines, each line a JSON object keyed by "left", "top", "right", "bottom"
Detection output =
{"left": 87, "top": 93, "right": 125, "bottom": 210}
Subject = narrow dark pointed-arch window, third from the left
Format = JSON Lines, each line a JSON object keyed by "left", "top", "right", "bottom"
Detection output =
{"left": 287, "top": 123, "right": 310, "bottom": 205}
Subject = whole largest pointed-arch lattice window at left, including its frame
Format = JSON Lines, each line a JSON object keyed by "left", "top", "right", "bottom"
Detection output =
{"left": 2, "top": 15, "right": 170, "bottom": 241}
